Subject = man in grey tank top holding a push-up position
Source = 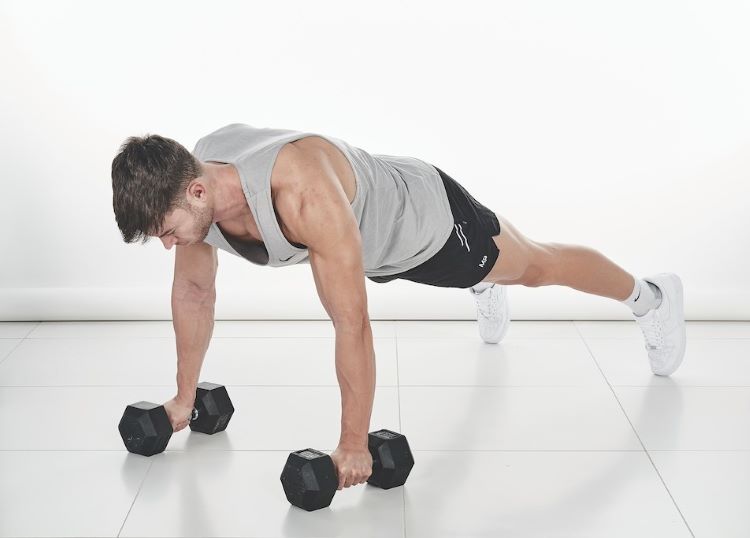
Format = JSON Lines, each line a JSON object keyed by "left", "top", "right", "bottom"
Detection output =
{"left": 112, "top": 124, "right": 685, "bottom": 489}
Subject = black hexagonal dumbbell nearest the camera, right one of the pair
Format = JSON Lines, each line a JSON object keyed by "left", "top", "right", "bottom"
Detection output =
{"left": 281, "top": 430, "right": 414, "bottom": 512}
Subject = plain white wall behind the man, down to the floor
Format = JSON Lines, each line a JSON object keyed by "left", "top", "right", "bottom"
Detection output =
{"left": 0, "top": 0, "right": 750, "bottom": 320}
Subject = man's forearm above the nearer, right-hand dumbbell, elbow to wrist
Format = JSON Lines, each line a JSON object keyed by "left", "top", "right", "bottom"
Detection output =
{"left": 336, "top": 320, "right": 375, "bottom": 448}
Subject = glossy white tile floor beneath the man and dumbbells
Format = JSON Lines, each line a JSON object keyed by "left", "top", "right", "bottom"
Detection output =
{"left": 0, "top": 321, "right": 750, "bottom": 538}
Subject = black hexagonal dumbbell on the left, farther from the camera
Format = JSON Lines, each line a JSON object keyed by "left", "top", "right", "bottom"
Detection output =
{"left": 118, "top": 381, "right": 234, "bottom": 456}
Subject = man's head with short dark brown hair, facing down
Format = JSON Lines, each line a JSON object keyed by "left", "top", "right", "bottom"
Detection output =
{"left": 112, "top": 135, "right": 214, "bottom": 248}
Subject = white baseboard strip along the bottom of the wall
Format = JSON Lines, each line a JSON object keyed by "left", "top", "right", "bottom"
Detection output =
{"left": 0, "top": 281, "right": 750, "bottom": 321}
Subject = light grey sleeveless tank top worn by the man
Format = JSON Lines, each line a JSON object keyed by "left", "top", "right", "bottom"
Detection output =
{"left": 193, "top": 123, "right": 453, "bottom": 277}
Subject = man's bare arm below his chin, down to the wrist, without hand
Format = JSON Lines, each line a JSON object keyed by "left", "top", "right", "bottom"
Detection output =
{"left": 172, "top": 243, "right": 218, "bottom": 407}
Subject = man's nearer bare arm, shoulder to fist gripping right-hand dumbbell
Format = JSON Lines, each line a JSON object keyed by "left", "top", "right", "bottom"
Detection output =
{"left": 288, "top": 144, "right": 375, "bottom": 489}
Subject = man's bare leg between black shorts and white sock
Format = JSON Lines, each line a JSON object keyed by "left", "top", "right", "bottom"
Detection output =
{"left": 483, "top": 215, "right": 635, "bottom": 301}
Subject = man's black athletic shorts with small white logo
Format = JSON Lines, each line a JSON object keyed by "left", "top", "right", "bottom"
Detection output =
{"left": 367, "top": 165, "right": 500, "bottom": 288}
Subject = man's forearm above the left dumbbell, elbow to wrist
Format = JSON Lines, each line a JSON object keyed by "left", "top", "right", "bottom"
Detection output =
{"left": 172, "top": 284, "right": 216, "bottom": 405}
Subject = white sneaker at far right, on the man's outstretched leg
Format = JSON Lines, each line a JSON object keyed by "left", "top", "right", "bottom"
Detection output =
{"left": 633, "top": 273, "right": 685, "bottom": 375}
